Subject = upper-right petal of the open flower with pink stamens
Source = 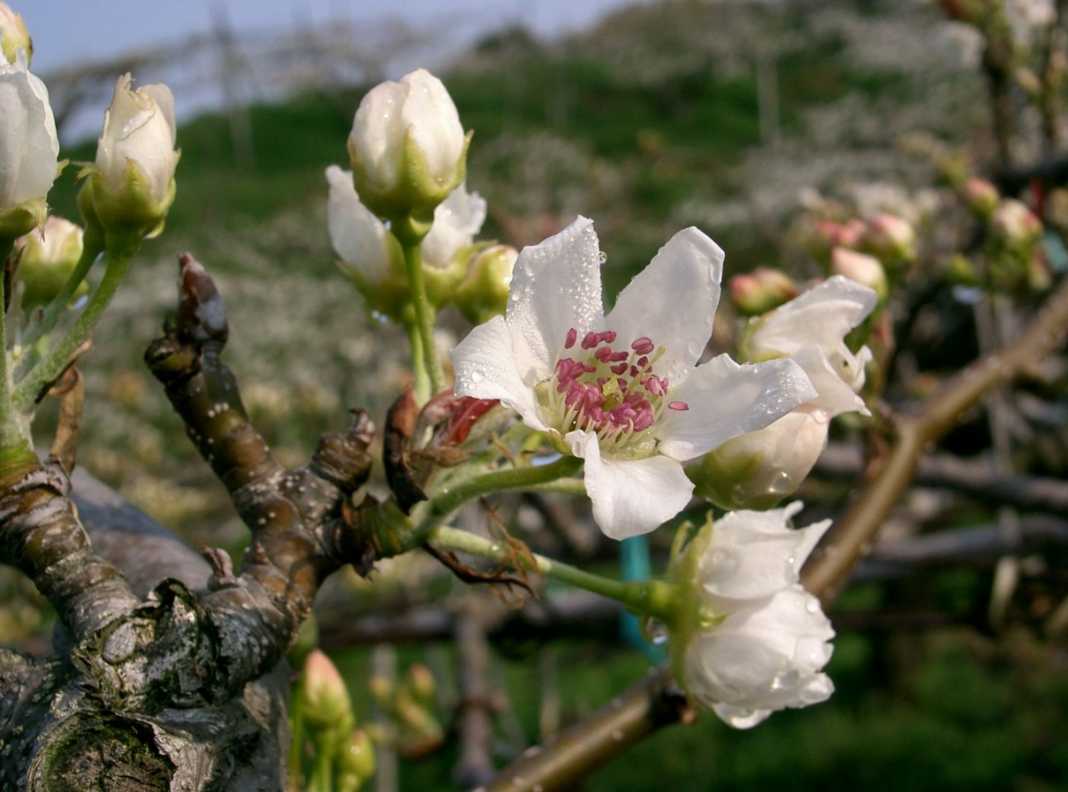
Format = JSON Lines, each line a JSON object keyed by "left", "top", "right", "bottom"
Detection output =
{"left": 606, "top": 226, "right": 723, "bottom": 382}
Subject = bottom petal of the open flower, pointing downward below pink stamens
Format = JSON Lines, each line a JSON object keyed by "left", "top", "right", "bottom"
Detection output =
{"left": 565, "top": 430, "right": 693, "bottom": 539}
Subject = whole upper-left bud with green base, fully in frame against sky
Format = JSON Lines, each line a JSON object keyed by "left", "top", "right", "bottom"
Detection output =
{"left": 89, "top": 75, "right": 178, "bottom": 237}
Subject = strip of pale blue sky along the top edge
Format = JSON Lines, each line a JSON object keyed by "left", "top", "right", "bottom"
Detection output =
{"left": 20, "top": 0, "right": 625, "bottom": 73}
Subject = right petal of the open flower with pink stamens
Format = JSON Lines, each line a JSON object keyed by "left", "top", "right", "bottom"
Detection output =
{"left": 656, "top": 354, "right": 816, "bottom": 461}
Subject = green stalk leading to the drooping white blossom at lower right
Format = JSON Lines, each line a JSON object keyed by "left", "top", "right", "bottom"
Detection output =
{"left": 429, "top": 525, "right": 676, "bottom": 623}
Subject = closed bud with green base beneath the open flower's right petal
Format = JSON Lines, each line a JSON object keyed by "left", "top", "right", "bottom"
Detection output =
{"left": 686, "top": 410, "right": 830, "bottom": 509}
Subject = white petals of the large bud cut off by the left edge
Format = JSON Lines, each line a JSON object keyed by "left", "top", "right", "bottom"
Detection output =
{"left": 0, "top": 64, "right": 60, "bottom": 220}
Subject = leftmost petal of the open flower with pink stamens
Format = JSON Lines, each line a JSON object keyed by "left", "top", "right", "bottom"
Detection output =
{"left": 452, "top": 316, "right": 547, "bottom": 431}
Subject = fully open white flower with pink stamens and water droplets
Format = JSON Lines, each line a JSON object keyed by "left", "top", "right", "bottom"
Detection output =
{"left": 453, "top": 218, "right": 816, "bottom": 539}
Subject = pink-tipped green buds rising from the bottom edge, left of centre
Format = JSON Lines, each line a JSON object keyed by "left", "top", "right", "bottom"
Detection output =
{"left": 289, "top": 649, "right": 375, "bottom": 792}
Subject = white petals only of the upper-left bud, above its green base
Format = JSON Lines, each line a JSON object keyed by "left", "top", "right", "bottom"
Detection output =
{"left": 94, "top": 74, "right": 178, "bottom": 205}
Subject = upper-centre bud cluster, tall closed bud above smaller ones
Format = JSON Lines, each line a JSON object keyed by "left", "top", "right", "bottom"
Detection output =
{"left": 327, "top": 69, "right": 517, "bottom": 321}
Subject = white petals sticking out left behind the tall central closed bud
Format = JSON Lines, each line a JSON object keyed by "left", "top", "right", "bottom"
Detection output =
{"left": 326, "top": 165, "right": 396, "bottom": 285}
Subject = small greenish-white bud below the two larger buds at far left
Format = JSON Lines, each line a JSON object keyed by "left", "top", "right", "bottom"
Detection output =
{"left": 16, "top": 216, "right": 88, "bottom": 311}
